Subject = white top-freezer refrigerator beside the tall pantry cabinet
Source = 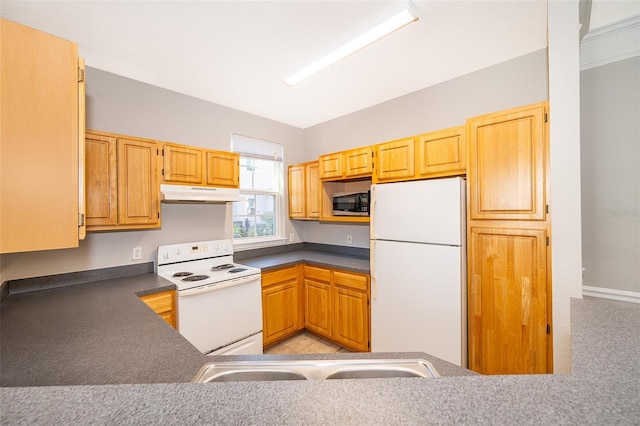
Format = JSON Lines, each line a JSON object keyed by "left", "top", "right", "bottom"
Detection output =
{"left": 370, "top": 177, "right": 467, "bottom": 367}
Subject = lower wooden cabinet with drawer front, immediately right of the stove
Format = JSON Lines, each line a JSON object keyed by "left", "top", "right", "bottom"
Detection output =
{"left": 262, "top": 265, "right": 304, "bottom": 346}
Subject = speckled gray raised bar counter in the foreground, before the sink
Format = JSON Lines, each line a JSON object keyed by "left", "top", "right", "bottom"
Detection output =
{"left": 0, "top": 299, "right": 640, "bottom": 425}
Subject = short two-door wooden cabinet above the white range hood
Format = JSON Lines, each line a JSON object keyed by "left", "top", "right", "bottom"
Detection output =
{"left": 162, "top": 142, "right": 240, "bottom": 188}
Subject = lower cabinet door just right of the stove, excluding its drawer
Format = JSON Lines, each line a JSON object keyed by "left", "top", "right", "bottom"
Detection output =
{"left": 262, "top": 280, "right": 299, "bottom": 345}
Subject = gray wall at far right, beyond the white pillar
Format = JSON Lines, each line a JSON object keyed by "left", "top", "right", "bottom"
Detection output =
{"left": 580, "top": 56, "right": 640, "bottom": 292}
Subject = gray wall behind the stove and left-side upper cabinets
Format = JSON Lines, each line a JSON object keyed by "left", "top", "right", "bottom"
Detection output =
{"left": 0, "top": 68, "right": 306, "bottom": 281}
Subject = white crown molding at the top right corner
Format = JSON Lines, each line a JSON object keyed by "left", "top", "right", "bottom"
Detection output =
{"left": 580, "top": 14, "right": 640, "bottom": 71}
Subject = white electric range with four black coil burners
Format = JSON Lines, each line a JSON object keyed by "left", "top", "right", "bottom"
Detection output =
{"left": 157, "top": 240, "right": 262, "bottom": 355}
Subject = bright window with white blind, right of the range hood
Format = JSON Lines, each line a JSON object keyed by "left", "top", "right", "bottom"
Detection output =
{"left": 231, "top": 134, "right": 284, "bottom": 243}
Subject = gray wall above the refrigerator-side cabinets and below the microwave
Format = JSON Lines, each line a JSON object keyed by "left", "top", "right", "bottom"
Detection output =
{"left": 304, "top": 49, "right": 548, "bottom": 247}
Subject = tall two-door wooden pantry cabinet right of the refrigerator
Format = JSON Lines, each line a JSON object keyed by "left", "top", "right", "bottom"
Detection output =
{"left": 467, "top": 102, "right": 553, "bottom": 374}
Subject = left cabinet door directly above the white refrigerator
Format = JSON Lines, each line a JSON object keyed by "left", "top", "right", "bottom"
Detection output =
{"left": 374, "top": 138, "right": 416, "bottom": 183}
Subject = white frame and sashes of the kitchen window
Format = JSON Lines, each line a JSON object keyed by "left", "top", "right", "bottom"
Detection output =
{"left": 231, "top": 133, "right": 286, "bottom": 249}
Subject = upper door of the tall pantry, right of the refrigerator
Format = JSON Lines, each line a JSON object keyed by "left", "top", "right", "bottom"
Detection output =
{"left": 467, "top": 103, "right": 548, "bottom": 220}
